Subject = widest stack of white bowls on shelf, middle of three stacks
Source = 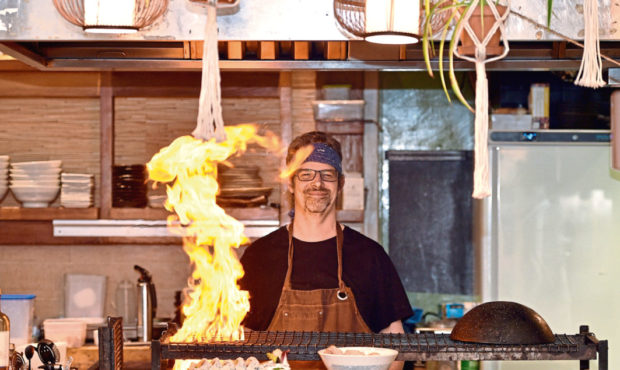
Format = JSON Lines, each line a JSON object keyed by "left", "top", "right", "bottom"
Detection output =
{"left": 9, "top": 161, "right": 62, "bottom": 208}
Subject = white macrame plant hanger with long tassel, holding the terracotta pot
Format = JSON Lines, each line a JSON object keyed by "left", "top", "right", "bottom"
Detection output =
{"left": 450, "top": 0, "right": 510, "bottom": 199}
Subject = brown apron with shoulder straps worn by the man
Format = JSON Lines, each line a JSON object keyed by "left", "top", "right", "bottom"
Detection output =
{"left": 267, "top": 223, "right": 371, "bottom": 333}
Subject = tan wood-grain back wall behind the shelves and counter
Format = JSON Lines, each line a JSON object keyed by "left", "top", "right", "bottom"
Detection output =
{"left": 0, "top": 67, "right": 316, "bottom": 322}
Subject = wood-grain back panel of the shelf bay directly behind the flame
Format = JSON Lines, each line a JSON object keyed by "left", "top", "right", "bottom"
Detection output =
{"left": 115, "top": 97, "right": 280, "bottom": 203}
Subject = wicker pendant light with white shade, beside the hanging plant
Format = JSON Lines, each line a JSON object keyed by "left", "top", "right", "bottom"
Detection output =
{"left": 334, "top": 0, "right": 420, "bottom": 44}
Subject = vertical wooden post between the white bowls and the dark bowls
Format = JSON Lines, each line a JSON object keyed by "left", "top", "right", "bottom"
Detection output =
{"left": 99, "top": 72, "right": 114, "bottom": 219}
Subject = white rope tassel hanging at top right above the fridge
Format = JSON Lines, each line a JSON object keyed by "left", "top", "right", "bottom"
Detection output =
{"left": 575, "top": 0, "right": 605, "bottom": 89}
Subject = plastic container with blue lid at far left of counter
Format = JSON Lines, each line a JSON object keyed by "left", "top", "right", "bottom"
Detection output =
{"left": 0, "top": 294, "right": 35, "bottom": 346}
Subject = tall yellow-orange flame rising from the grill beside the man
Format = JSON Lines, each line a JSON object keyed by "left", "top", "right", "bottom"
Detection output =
{"left": 147, "top": 124, "right": 280, "bottom": 369}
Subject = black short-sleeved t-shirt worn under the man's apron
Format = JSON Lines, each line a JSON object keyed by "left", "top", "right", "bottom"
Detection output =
{"left": 239, "top": 227, "right": 413, "bottom": 332}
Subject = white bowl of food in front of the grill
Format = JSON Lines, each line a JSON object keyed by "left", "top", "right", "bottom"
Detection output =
{"left": 319, "top": 346, "right": 398, "bottom": 370}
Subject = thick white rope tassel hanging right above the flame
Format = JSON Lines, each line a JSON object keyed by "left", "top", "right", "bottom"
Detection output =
{"left": 192, "top": 0, "right": 226, "bottom": 142}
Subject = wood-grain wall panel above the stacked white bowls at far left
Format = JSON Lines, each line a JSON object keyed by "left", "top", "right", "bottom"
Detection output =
{"left": 0, "top": 98, "right": 99, "bottom": 206}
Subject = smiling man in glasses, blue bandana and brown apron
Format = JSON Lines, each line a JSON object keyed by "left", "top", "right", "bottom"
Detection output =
{"left": 239, "top": 131, "right": 413, "bottom": 344}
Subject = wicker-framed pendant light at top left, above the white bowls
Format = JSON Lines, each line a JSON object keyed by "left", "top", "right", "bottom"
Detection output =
{"left": 54, "top": 0, "right": 168, "bottom": 33}
